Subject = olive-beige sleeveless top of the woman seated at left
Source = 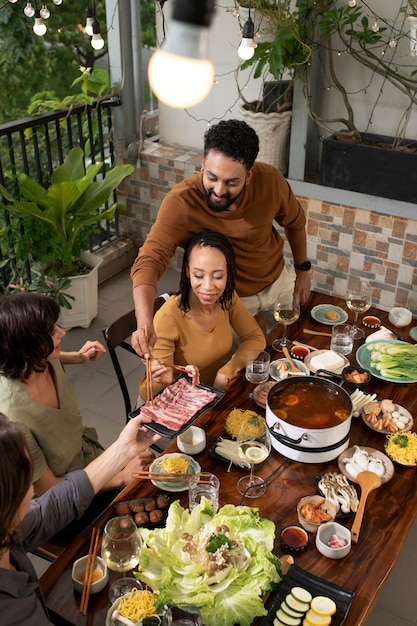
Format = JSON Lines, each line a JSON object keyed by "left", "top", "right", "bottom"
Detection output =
{"left": 0, "top": 359, "right": 104, "bottom": 481}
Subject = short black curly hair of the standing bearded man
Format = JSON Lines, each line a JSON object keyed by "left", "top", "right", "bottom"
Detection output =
{"left": 204, "top": 120, "right": 259, "bottom": 171}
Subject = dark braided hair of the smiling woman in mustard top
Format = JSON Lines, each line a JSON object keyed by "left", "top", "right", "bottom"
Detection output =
{"left": 178, "top": 230, "right": 236, "bottom": 313}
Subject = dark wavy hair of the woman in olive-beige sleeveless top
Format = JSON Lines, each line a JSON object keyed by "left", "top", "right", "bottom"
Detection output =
{"left": 0, "top": 291, "right": 59, "bottom": 382}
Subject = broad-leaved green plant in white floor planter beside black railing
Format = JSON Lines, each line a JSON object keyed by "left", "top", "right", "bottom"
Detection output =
{"left": 0, "top": 147, "right": 134, "bottom": 328}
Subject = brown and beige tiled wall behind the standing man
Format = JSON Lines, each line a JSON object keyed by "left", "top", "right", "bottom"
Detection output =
{"left": 119, "top": 141, "right": 417, "bottom": 317}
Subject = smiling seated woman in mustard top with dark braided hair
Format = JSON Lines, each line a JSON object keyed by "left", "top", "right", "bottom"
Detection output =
{"left": 140, "top": 231, "right": 265, "bottom": 399}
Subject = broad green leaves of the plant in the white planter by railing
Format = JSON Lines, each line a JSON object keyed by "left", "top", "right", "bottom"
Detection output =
{"left": 0, "top": 148, "right": 134, "bottom": 277}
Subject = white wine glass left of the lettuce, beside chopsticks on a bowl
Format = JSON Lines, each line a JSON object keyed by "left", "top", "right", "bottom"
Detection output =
{"left": 101, "top": 515, "right": 142, "bottom": 604}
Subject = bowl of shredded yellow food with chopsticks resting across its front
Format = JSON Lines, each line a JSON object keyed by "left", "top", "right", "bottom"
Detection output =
{"left": 149, "top": 452, "right": 201, "bottom": 491}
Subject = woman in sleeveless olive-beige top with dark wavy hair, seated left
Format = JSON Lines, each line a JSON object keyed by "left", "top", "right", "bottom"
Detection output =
{"left": 0, "top": 292, "right": 153, "bottom": 495}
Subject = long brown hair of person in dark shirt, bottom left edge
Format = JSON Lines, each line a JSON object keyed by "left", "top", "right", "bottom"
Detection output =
{"left": 0, "top": 413, "right": 33, "bottom": 552}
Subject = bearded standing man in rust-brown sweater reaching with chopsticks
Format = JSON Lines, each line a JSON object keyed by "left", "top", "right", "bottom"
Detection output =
{"left": 131, "top": 120, "right": 311, "bottom": 358}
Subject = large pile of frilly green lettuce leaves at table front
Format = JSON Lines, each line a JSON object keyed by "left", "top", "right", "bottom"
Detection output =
{"left": 135, "top": 498, "right": 282, "bottom": 626}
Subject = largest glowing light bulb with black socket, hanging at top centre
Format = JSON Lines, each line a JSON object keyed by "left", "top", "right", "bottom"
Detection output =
{"left": 148, "top": 0, "right": 214, "bottom": 109}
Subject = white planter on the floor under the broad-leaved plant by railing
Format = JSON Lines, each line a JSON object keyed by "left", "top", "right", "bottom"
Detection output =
{"left": 58, "top": 252, "right": 103, "bottom": 330}
